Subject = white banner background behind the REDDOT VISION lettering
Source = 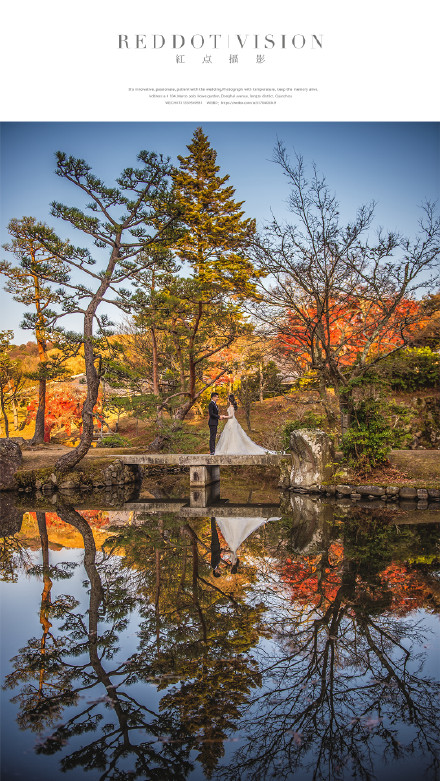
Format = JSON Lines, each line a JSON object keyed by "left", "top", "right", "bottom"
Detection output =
{"left": 0, "top": 0, "right": 439, "bottom": 121}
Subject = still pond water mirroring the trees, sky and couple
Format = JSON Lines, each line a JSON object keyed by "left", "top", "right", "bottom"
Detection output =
{"left": 0, "top": 480, "right": 440, "bottom": 781}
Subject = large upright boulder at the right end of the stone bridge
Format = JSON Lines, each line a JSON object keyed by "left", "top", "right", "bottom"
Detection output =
{"left": 290, "top": 429, "right": 335, "bottom": 488}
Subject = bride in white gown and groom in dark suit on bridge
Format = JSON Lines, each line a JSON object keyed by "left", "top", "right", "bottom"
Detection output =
{"left": 208, "top": 393, "right": 269, "bottom": 456}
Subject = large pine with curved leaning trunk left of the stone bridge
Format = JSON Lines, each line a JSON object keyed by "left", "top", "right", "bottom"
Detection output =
{"left": 32, "top": 150, "right": 177, "bottom": 473}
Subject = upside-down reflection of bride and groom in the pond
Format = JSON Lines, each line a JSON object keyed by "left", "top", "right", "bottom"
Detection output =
{"left": 211, "top": 516, "right": 279, "bottom": 578}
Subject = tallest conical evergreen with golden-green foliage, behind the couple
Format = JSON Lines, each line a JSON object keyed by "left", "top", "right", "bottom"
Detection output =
{"left": 156, "top": 128, "right": 259, "bottom": 420}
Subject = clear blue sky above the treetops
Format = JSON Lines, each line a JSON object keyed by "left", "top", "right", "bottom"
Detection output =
{"left": 0, "top": 122, "right": 440, "bottom": 342}
